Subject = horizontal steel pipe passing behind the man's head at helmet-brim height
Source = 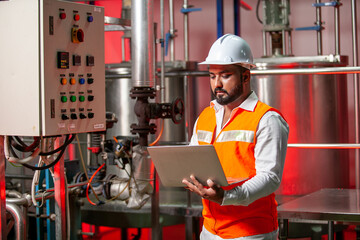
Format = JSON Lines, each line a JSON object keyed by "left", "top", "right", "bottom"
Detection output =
{"left": 105, "top": 67, "right": 360, "bottom": 79}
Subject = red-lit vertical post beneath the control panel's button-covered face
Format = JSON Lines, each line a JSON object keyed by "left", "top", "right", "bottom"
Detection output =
{"left": 54, "top": 138, "right": 67, "bottom": 240}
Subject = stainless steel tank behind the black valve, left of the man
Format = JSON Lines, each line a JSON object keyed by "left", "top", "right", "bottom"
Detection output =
{"left": 106, "top": 62, "right": 189, "bottom": 144}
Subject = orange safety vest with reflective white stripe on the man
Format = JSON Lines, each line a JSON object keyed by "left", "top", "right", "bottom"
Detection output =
{"left": 196, "top": 101, "right": 278, "bottom": 239}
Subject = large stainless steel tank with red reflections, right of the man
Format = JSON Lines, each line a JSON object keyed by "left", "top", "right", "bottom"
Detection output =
{"left": 251, "top": 56, "right": 349, "bottom": 195}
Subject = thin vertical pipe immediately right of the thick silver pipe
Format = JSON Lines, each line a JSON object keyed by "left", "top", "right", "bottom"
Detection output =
{"left": 160, "top": 0, "right": 165, "bottom": 103}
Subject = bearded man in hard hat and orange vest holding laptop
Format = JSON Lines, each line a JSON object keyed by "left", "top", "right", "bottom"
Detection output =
{"left": 183, "top": 34, "right": 289, "bottom": 240}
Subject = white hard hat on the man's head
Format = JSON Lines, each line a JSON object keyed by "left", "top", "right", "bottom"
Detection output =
{"left": 199, "top": 34, "right": 255, "bottom": 69}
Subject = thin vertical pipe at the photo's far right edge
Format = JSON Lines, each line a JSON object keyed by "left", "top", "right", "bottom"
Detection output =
{"left": 351, "top": 0, "right": 360, "bottom": 189}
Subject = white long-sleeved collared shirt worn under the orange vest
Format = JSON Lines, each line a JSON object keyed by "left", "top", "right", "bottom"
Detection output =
{"left": 190, "top": 92, "right": 289, "bottom": 206}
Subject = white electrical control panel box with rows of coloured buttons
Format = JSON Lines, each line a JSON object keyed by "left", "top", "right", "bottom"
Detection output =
{"left": 0, "top": 0, "right": 106, "bottom": 136}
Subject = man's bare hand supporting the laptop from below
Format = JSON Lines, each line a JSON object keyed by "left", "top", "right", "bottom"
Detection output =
{"left": 182, "top": 175, "right": 224, "bottom": 205}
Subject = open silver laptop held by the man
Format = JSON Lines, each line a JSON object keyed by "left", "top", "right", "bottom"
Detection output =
{"left": 148, "top": 145, "right": 228, "bottom": 187}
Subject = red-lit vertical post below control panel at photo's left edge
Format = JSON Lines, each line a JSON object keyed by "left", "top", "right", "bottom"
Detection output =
{"left": 0, "top": 136, "right": 7, "bottom": 240}
